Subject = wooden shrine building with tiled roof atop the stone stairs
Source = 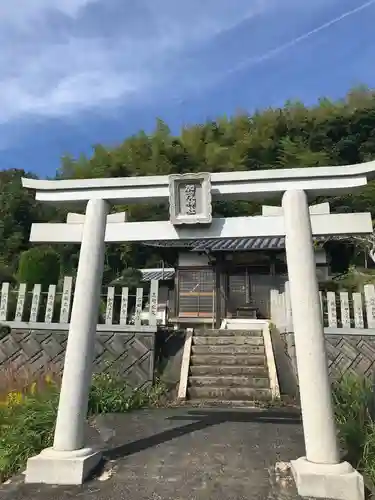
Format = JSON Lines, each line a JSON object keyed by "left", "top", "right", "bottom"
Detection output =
{"left": 145, "top": 238, "right": 329, "bottom": 324}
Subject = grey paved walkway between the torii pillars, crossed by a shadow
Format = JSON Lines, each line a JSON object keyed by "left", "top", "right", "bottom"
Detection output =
{"left": 0, "top": 407, "right": 304, "bottom": 500}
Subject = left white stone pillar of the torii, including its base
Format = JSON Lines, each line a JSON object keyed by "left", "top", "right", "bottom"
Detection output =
{"left": 26, "top": 199, "right": 108, "bottom": 484}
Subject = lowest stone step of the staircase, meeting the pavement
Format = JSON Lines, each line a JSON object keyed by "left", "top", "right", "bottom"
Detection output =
{"left": 187, "top": 386, "right": 272, "bottom": 401}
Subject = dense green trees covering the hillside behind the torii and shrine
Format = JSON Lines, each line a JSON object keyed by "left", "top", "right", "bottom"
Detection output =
{"left": 0, "top": 88, "right": 375, "bottom": 283}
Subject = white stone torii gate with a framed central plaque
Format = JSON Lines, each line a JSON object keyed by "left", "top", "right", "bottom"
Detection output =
{"left": 22, "top": 162, "right": 375, "bottom": 500}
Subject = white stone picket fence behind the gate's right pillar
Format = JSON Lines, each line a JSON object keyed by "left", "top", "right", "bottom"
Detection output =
{"left": 270, "top": 282, "right": 375, "bottom": 335}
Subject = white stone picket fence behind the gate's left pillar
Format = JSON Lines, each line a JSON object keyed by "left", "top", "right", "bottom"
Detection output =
{"left": 0, "top": 276, "right": 167, "bottom": 329}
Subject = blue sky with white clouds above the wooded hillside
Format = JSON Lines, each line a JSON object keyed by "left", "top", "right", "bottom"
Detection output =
{"left": 0, "top": 0, "right": 375, "bottom": 177}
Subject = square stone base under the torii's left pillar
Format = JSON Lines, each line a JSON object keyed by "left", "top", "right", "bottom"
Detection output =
{"left": 25, "top": 448, "right": 102, "bottom": 485}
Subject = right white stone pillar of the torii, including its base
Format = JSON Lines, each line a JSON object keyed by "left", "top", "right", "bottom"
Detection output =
{"left": 282, "top": 190, "right": 361, "bottom": 500}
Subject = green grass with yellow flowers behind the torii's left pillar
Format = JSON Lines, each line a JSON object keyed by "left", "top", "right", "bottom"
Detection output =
{"left": 0, "top": 373, "right": 164, "bottom": 481}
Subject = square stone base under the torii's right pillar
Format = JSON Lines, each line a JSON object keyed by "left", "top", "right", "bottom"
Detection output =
{"left": 291, "top": 457, "right": 365, "bottom": 500}
